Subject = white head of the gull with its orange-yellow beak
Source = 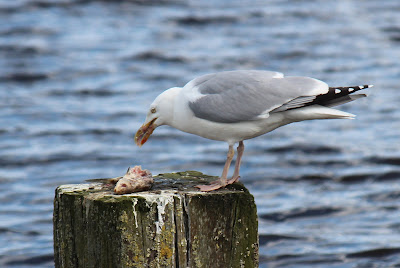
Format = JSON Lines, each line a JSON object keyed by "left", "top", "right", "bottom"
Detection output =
{"left": 135, "top": 87, "right": 182, "bottom": 147}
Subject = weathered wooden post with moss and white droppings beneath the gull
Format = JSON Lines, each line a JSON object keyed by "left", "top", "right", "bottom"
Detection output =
{"left": 53, "top": 171, "right": 258, "bottom": 268}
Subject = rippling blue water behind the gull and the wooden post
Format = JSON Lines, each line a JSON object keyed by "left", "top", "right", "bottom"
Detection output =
{"left": 0, "top": 0, "right": 400, "bottom": 267}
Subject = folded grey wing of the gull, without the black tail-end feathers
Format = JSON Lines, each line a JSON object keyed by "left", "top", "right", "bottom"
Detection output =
{"left": 185, "top": 71, "right": 328, "bottom": 123}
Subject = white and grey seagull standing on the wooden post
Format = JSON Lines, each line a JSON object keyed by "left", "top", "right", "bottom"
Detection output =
{"left": 135, "top": 70, "right": 372, "bottom": 191}
